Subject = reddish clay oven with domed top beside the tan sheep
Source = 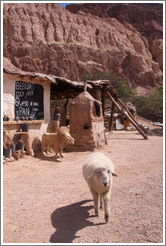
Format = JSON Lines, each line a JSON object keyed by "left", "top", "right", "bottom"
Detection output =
{"left": 70, "top": 91, "right": 105, "bottom": 150}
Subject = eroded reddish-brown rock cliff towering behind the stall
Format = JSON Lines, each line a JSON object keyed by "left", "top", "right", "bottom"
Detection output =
{"left": 3, "top": 3, "right": 163, "bottom": 94}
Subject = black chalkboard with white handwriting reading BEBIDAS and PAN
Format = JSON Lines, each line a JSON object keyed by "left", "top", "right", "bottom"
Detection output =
{"left": 15, "top": 81, "right": 44, "bottom": 120}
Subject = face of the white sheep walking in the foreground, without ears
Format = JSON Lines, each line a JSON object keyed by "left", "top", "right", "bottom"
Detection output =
{"left": 94, "top": 168, "right": 112, "bottom": 187}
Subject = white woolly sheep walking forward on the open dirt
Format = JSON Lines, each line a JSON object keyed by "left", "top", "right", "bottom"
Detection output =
{"left": 82, "top": 152, "right": 118, "bottom": 222}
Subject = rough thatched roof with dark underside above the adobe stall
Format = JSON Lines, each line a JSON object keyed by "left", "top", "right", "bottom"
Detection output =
{"left": 3, "top": 57, "right": 108, "bottom": 99}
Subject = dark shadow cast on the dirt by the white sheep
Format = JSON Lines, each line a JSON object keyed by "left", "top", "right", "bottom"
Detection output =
{"left": 50, "top": 200, "right": 105, "bottom": 243}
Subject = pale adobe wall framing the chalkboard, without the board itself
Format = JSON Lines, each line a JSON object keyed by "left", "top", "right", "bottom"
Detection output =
{"left": 3, "top": 74, "right": 50, "bottom": 149}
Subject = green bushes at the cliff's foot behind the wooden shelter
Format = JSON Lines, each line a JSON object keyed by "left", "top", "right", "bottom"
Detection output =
{"left": 82, "top": 70, "right": 163, "bottom": 122}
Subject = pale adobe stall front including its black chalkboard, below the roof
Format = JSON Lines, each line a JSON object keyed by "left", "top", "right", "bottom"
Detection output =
{"left": 3, "top": 73, "right": 50, "bottom": 151}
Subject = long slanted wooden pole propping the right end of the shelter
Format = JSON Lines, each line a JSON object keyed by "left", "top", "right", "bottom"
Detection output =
{"left": 107, "top": 91, "right": 148, "bottom": 139}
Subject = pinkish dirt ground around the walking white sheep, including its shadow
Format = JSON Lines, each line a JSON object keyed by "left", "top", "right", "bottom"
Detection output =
{"left": 3, "top": 131, "right": 163, "bottom": 243}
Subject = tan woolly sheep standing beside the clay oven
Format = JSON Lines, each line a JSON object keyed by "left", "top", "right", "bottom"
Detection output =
{"left": 42, "top": 126, "right": 74, "bottom": 157}
